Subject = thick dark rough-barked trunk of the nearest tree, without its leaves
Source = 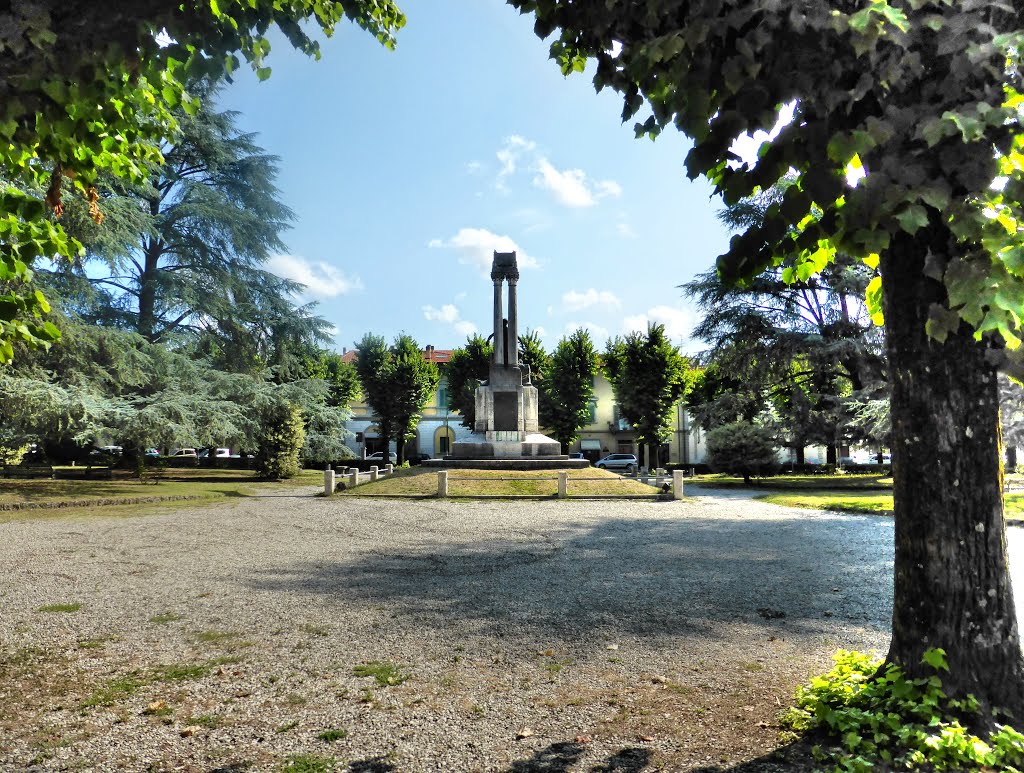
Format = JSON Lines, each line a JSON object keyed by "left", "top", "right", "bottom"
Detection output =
{"left": 881, "top": 230, "right": 1024, "bottom": 718}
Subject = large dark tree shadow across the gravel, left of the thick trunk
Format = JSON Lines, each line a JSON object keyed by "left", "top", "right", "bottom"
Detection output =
{"left": 243, "top": 514, "right": 893, "bottom": 640}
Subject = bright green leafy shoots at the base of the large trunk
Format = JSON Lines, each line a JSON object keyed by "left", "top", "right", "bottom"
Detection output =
{"left": 781, "top": 649, "right": 1024, "bottom": 773}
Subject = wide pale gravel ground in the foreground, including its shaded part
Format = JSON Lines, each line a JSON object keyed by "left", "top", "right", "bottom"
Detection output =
{"left": 0, "top": 489, "right": 1024, "bottom": 773}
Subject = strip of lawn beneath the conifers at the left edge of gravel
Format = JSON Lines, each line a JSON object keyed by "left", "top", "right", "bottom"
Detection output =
{"left": 0, "top": 469, "right": 324, "bottom": 521}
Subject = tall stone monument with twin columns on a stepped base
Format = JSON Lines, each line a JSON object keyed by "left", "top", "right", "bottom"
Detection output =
{"left": 438, "top": 251, "right": 586, "bottom": 467}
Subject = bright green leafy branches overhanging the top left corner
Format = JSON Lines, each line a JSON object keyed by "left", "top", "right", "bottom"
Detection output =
{"left": 0, "top": 0, "right": 406, "bottom": 361}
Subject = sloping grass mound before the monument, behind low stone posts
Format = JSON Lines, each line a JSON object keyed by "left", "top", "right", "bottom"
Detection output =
{"left": 342, "top": 467, "right": 658, "bottom": 499}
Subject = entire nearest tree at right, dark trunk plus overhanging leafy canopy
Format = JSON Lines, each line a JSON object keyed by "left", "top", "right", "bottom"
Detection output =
{"left": 509, "top": 0, "right": 1024, "bottom": 722}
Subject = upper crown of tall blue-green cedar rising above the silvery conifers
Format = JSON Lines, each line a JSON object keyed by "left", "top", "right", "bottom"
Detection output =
{"left": 41, "top": 83, "right": 327, "bottom": 371}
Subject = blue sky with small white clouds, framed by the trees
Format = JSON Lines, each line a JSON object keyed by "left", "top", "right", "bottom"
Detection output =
{"left": 220, "top": 0, "right": 741, "bottom": 351}
